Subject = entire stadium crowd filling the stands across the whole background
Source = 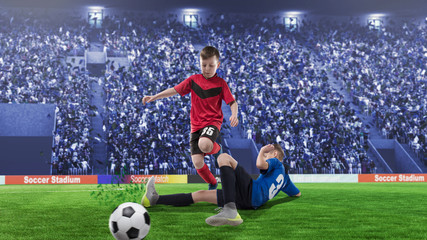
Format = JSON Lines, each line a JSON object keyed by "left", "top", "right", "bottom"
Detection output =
{"left": 0, "top": 9, "right": 427, "bottom": 174}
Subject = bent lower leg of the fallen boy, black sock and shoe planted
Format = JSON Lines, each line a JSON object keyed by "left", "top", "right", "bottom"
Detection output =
{"left": 206, "top": 154, "right": 243, "bottom": 226}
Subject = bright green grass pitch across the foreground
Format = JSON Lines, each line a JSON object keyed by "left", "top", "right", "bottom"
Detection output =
{"left": 0, "top": 183, "right": 427, "bottom": 240}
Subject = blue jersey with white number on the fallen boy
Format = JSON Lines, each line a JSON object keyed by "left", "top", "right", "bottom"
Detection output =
{"left": 252, "top": 158, "right": 299, "bottom": 208}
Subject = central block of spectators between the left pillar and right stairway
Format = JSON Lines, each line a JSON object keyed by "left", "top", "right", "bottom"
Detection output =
{"left": 98, "top": 15, "right": 372, "bottom": 173}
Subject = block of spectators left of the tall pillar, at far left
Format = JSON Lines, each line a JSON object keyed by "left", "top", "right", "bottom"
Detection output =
{"left": 0, "top": 10, "right": 93, "bottom": 174}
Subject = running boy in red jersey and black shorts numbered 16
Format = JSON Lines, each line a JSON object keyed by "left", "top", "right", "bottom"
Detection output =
{"left": 142, "top": 46, "right": 239, "bottom": 190}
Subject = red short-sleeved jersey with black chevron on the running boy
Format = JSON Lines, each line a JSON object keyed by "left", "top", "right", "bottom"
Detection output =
{"left": 174, "top": 74, "right": 235, "bottom": 132}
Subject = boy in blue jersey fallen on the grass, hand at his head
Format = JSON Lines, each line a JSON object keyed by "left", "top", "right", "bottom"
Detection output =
{"left": 141, "top": 144, "right": 301, "bottom": 226}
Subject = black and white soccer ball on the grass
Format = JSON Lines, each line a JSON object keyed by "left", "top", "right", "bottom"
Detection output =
{"left": 109, "top": 202, "right": 150, "bottom": 240}
